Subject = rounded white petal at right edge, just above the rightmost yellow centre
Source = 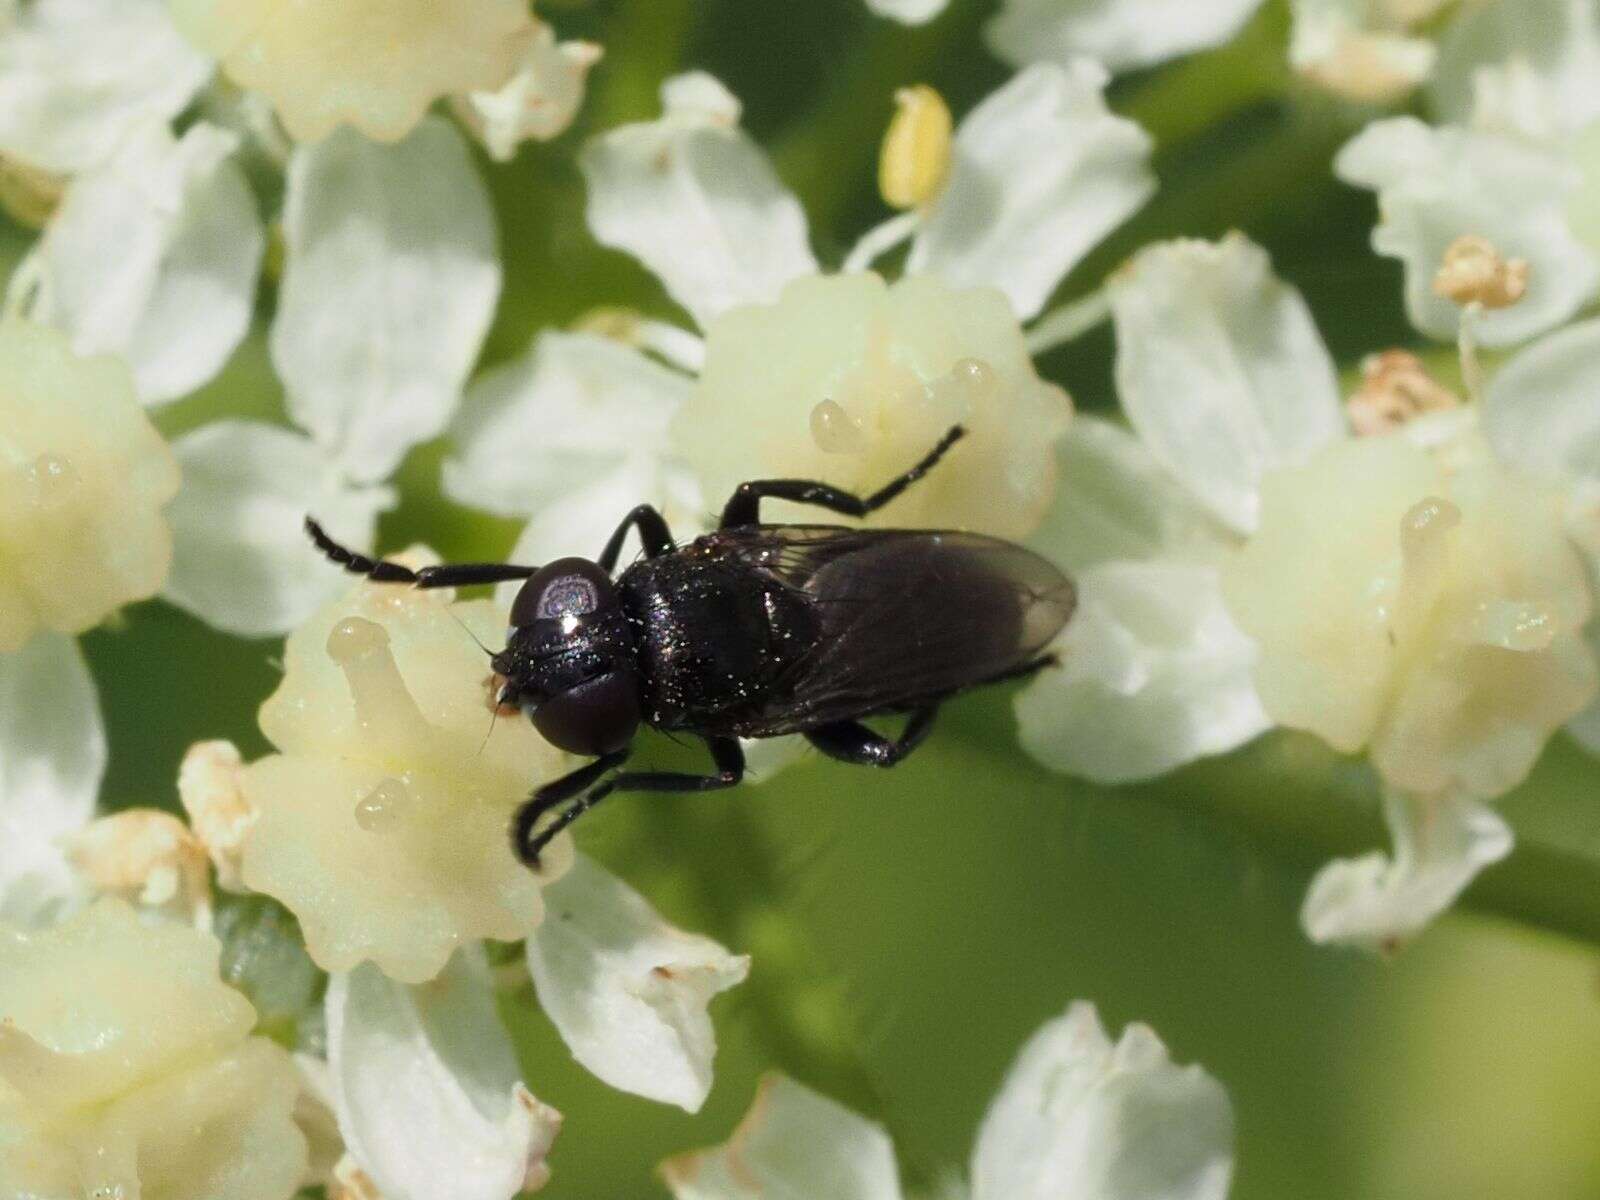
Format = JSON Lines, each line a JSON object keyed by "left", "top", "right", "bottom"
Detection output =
{"left": 1483, "top": 320, "right": 1600, "bottom": 480}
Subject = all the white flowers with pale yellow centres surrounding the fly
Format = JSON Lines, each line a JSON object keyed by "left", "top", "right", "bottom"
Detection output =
{"left": 0, "top": 0, "right": 1600, "bottom": 1200}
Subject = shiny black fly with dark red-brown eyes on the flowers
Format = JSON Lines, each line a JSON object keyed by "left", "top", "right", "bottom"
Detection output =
{"left": 306, "top": 426, "right": 1075, "bottom": 866}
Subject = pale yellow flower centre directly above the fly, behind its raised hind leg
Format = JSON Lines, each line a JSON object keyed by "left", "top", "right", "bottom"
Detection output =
{"left": 672, "top": 272, "right": 1072, "bottom": 538}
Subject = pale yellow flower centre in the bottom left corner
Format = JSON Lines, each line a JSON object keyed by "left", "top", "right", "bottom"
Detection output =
{"left": 0, "top": 899, "right": 306, "bottom": 1200}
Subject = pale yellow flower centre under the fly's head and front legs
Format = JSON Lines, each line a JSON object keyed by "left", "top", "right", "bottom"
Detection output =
{"left": 243, "top": 560, "right": 571, "bottom": 982}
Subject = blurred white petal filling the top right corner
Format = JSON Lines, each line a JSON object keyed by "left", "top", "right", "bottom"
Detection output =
{"left": 1430, "top": 0, "right": 1600, "bottom": 133}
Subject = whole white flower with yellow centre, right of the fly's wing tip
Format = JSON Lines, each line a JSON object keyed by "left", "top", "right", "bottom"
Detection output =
{"left": 1018, "top": 232, "right": 1600, "bottom": 947}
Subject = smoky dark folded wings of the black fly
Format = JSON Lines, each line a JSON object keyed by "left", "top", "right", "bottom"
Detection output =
{"left": 712, "top": 525, "right": 1075, "bottom": 733}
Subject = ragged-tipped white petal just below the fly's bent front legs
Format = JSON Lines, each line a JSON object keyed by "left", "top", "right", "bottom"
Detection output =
{"left": 528, "top": 856, "right": 750, "bottom": 1112}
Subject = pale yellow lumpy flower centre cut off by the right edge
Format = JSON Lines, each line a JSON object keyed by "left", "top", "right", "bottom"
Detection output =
{"left": 1222, "top": 435, "right": 1597, "bottom": 798}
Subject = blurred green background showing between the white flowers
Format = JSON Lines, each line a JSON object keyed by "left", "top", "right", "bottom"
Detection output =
{"left": 12, "top": 0, "right": 1600, "bottom": 1200}
